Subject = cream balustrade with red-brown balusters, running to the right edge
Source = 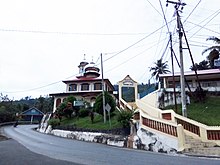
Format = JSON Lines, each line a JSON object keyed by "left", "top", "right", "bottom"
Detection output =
{"left": 136, "top": 93, "right": 220, "bottom": 145}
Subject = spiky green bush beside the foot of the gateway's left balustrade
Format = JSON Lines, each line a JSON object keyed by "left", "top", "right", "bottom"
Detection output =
{"left": 117, "top": 110, "right": 134, "bottom": 128}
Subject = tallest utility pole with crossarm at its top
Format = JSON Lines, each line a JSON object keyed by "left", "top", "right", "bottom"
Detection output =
{"left": 167, "top": 0, "right": 187, "bottom": 117}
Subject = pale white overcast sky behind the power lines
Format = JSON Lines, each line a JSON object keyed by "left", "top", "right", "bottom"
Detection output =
{"left": 0, "top": 0, "right": 220, "bottom": 99}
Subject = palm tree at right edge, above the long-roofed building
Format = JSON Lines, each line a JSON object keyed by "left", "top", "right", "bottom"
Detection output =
{"left": 202, "top": 36, "right": 220, "bottom": 68}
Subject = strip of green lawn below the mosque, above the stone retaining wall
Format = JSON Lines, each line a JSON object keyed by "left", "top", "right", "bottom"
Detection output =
{"left": 61, "top": 114, "right": 122, "bottom": 130}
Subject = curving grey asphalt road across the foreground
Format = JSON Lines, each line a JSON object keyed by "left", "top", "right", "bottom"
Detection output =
{"left": 0, "top": 125, "right": 220, "bottom": 165}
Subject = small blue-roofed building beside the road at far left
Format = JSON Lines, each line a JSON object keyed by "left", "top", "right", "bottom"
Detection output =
{"left": 20, "top": 107, "right": 44, "bottom": 123}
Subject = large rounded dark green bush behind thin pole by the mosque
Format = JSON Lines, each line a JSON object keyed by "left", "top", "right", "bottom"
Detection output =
{"left": 93, "top": 92, "right": 116, "bottom": 115}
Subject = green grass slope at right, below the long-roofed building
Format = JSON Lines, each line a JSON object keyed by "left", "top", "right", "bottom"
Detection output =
{"left": 166, "top": 96, "right": 220, "bottom": 126}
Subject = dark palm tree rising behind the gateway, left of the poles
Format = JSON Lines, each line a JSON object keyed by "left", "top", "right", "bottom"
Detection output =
{"left": 150, "top": 58, "right": 170, "bottom": 80}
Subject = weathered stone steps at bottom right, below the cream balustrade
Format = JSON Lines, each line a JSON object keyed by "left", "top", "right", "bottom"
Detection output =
{"left": 183, "top": 135, "right": 220, "bottom": 157}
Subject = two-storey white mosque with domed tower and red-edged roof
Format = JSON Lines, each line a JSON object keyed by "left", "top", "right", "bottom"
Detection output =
{"left": 50, "top": 56, "right": 114, "bottom": 112}
